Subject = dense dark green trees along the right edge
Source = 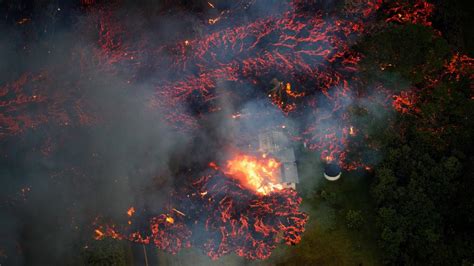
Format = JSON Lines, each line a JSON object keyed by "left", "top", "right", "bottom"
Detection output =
{"left": 358, "top": 21, "right": 474, "bottom": 265}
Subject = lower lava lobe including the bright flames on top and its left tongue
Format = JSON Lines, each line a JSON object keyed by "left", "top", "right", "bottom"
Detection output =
{"left": 96, "top": 155, "right": 308, "bottom": 259}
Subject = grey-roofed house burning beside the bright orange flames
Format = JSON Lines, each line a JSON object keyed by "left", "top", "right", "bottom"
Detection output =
{"left": 258, "top": 130, "right": 298, "bottom": 189}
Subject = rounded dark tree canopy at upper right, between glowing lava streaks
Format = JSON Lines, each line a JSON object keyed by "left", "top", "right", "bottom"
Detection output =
{"left": 355, "top": 24, "right": 450, "bottom": 88}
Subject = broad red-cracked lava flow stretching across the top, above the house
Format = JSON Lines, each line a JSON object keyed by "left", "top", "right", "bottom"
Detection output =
{"left": 0, "top": 0, "right": 433, "bottom": 168}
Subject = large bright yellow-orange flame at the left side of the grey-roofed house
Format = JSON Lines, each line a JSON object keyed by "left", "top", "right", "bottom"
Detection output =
{"left": 224, "top": 155, "right": 283, "bottom": 195}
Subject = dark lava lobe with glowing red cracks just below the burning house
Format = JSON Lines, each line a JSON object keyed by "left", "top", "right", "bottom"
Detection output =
{"left": 191, "top": 171, "right": 308, "bottom": 259}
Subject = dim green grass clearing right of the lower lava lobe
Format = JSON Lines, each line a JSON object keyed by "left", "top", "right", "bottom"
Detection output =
{"left": 260, "top": 149, "right": 381, "bottom": 265}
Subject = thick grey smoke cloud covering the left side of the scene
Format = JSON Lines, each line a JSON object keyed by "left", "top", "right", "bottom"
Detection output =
{"left": 0, "top": 2, "right": 200, "bottom": 265}
